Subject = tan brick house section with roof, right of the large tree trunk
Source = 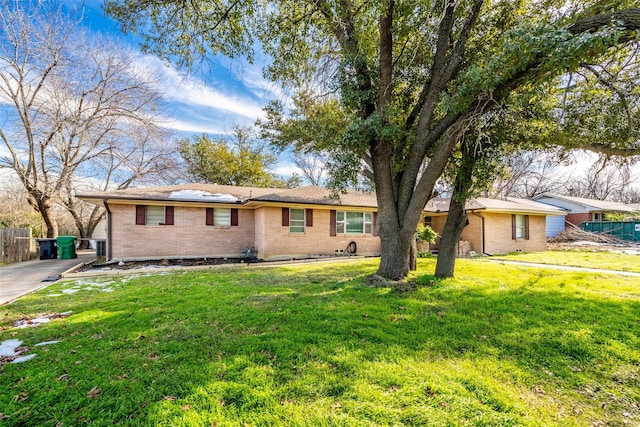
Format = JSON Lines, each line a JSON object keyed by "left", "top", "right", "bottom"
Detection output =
{"left": 424, "top": 198, "right": 565, "bottom": 256}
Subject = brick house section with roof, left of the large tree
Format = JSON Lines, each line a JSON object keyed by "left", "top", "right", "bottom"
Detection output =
{"left": 78, "top": 184, "right": 380, "bottom": 260}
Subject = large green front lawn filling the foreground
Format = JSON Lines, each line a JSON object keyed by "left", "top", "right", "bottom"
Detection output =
{"left": 0, "top": 259, "right": 640, "bottom": 426}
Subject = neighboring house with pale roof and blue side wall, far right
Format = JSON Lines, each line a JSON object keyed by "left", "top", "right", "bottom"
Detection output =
{"left": 533, "top": 193, "right": 635, "bottom": 237}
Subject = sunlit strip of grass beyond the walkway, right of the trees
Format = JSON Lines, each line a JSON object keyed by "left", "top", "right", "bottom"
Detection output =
{"left": 496, "top": 250, "right": 640, "bottom": 273}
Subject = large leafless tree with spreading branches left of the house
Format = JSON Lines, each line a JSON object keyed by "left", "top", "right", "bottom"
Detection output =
{"left": 0, "top": 1, "right": 175, "bottom": 237}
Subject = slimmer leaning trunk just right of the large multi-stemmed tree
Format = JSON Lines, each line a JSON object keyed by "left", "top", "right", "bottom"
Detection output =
{"left": 435, "top": 199, "right": 467, "bottom": 278}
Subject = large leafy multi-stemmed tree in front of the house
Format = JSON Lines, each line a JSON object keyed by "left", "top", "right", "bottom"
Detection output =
{"left": 102, "top": 0, "right": 640, "bottom": 279}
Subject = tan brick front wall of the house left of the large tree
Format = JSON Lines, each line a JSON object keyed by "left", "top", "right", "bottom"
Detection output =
{"left": 110, "top": 204, "right": 380, "bottom": 259}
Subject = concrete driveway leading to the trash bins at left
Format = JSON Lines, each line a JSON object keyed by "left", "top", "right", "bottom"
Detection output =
{"left": 0, "top": 250, "right": 96, "bottom": 305}
